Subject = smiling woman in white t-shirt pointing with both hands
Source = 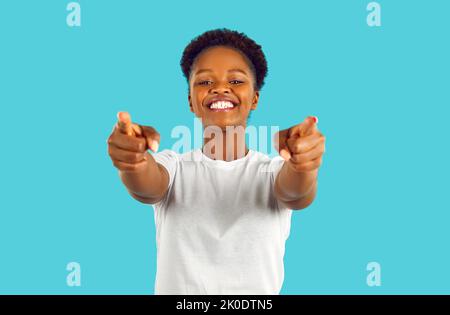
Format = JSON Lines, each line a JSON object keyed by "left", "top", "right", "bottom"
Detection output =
{"left": 111, "top": 29, "right": 323, "bottom": 295}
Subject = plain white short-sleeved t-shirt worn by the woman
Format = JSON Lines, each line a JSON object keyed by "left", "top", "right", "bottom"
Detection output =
{"left": 153, "top": 148, "right": 292, "bottom": 295}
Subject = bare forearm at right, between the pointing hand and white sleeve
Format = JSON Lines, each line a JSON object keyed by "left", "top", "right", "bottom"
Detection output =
{"left": 274, "top": 162, "right": 318, "bottom": 210}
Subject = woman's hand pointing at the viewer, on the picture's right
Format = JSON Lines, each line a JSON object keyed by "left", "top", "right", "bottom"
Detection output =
{"left": 274, "top": 116, "right": 325, "bottom": 172}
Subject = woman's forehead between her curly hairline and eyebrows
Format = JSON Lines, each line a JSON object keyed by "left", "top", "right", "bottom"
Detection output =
{"left": 192, "top": 46, "right": 250, "bottom": 75}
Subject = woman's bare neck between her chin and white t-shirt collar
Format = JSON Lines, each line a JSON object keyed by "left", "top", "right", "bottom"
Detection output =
{"left": 202, "top": 126, "right": 248, "bottom": 161}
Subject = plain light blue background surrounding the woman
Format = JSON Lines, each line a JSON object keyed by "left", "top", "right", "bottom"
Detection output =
{"left": 0, "top": 0, "right": 450, "bottom": 294}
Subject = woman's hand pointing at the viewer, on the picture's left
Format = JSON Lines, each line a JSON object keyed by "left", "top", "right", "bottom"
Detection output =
{"left": 107, "top": 112, "right": 160, "bottom": 172}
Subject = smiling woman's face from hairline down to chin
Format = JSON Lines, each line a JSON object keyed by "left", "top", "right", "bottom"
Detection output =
{"left": 188, "top": 46, "right": 259, "bottom": 130}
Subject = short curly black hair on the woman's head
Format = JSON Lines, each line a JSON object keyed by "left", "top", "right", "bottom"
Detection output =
{"left": 180, "top": 28, "right": 267, "bottom": 91}
